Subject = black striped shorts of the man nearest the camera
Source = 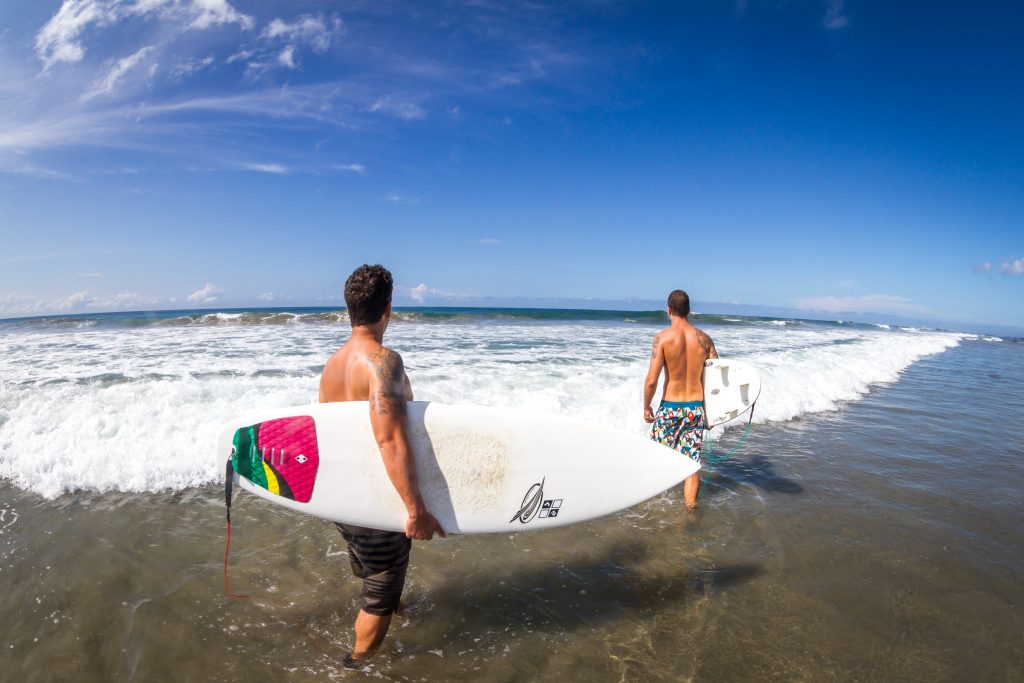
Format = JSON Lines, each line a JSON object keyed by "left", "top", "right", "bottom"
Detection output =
{"left": 335, "top": 523, "right": 413, "bottom": 616}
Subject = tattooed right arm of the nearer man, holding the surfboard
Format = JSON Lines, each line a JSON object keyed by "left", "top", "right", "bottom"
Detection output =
{"left": 370, "top": 348, "right": 444, "bottom": 541}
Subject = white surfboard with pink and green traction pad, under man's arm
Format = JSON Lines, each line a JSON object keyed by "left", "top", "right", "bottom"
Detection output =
{"left": 216, "top": 401, "right": 698, "bottom": 533}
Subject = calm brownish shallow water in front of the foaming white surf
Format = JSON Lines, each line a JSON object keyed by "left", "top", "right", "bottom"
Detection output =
{"left": 0, "top": 313, "right": 1024, "bottom": 682}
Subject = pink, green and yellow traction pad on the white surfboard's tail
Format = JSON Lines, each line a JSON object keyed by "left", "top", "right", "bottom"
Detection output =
{"left": 231, "top": 415, "right": 319, "bottom": 503}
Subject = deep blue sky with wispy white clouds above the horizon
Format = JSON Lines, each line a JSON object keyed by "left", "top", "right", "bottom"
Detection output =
{"left": 0, "top": 0, "right": 1024, "bottom": 327}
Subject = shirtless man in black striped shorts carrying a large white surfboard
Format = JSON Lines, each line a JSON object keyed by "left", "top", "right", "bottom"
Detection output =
{"left": 319, "top": 265, "right": 444, "bottom": 667}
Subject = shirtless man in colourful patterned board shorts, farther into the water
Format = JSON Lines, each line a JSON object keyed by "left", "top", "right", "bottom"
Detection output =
{"left": 643, "top": 290, "right": 718, "bottom": 510}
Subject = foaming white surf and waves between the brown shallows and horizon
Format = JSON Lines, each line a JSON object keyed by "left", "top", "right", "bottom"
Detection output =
{"left": 0, "top": 308, "right": 970, "bottom": 498}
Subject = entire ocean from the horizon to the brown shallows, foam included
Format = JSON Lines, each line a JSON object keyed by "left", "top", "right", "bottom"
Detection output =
{"left": 0, "top": 309, "right": 1024, "bottom": 681}
